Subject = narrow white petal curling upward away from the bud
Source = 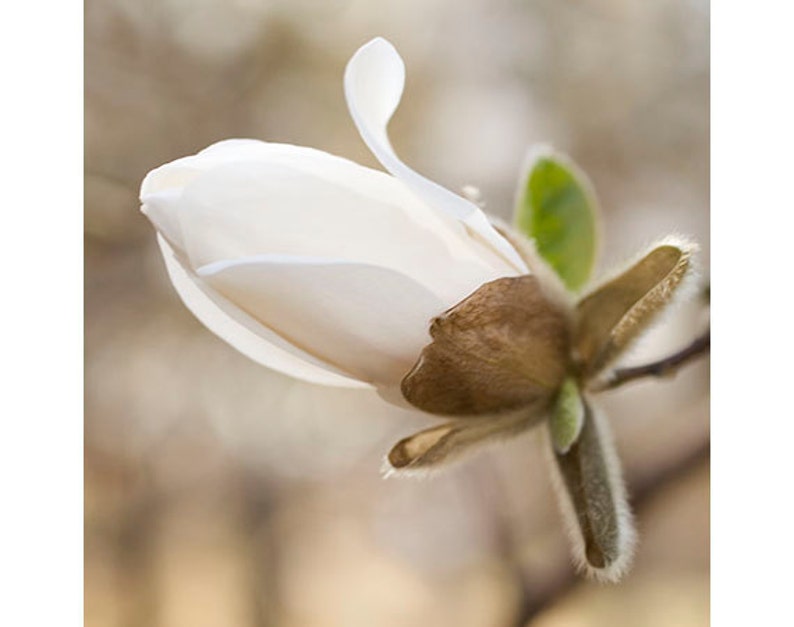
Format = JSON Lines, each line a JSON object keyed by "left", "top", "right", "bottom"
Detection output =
{"left": 345, "top": 37, "right": 527, "bottom": 273}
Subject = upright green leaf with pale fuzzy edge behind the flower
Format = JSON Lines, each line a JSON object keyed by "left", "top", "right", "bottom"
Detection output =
{"left": 515, "top": 146, "right": 598, "bottom": 292}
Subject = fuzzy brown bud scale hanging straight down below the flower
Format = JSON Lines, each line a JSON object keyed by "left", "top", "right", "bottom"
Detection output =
{"left": 553, "top": 402, "right": 635, "bottom": 581}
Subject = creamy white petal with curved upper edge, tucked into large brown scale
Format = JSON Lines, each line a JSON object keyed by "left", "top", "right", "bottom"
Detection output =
{"left": 198, "top": 255, "right": 445, "bottom": 386}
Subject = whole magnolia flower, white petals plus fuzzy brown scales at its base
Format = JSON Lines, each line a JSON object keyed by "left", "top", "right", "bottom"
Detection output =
{"left": 141, "top": 39, "right": 692, "bottom": 579}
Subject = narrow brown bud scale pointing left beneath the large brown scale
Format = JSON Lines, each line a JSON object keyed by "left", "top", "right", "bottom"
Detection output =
{"left": 388, "top": 408, "right": 546, "bottom": 471}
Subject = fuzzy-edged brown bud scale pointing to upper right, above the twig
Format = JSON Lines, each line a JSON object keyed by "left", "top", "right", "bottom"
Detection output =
{"left": 575, "top": 241, "right": 695, "bottom": 377}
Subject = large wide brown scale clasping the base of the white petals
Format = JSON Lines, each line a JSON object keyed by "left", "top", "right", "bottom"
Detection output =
{"left": 401, "top": 276, "right": 569, "bottom": 416}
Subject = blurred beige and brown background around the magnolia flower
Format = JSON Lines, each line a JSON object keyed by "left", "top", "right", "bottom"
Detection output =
{"left": 85, "top": 0, "right": 709, "bottom": 627}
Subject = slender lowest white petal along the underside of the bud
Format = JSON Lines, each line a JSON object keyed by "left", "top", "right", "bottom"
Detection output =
{"left": 157, "top": 237, "right": 371, "bottom": 388}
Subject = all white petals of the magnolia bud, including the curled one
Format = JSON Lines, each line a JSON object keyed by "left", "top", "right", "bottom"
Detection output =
{"left": 141, "top": 38, "right": 528, "bottom": 399}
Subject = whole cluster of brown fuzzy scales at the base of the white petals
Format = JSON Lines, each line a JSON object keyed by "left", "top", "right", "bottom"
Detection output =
{"left": 388, "top": 234, "right": 695, "bottom": 581}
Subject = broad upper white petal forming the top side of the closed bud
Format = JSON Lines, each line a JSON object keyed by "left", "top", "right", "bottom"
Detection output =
{"left": 173, "top": 157, "right": 514, "bottom": 306}
